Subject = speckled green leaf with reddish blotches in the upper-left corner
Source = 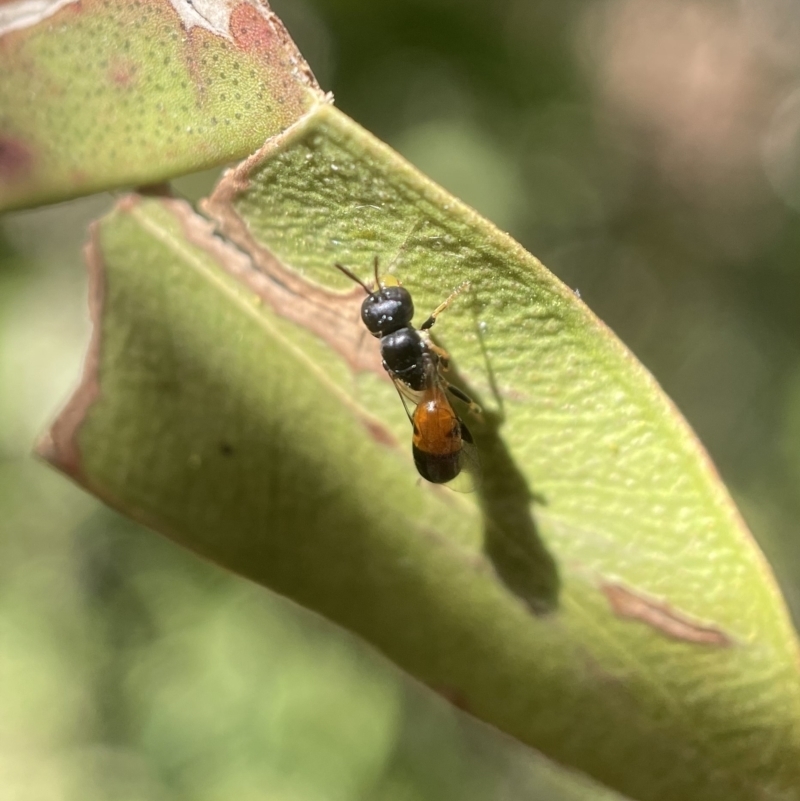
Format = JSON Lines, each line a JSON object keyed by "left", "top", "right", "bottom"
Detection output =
{"left": 0, "top": 0, "right": 324, "bottom": 210}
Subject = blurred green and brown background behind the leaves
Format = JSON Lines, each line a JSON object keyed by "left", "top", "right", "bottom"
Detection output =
{"left": 0, "top": 0, "right": 800, "bottom": 801}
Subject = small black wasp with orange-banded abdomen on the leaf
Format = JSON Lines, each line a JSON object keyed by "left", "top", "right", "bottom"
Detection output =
{"left": 335, "top": 256, "right": 480, "bottom": 491}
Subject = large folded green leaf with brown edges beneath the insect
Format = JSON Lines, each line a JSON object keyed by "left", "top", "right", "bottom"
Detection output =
{"left": 42, "top": 106, "right": 800, "bottom": 801}
